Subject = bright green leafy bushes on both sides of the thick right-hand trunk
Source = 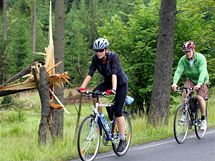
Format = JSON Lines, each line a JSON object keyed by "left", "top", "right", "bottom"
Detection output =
{"left": 99, "top": 0, "right": 215, "bottom": 114}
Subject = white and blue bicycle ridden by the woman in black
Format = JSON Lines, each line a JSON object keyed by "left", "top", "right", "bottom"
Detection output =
{"left": 77, "top": 91, "right": 132, "bottom": 161}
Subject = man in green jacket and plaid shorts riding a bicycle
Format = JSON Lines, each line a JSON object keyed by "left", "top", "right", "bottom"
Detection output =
{"left": 172, "top": 41, "right": 209, "bottom": 130}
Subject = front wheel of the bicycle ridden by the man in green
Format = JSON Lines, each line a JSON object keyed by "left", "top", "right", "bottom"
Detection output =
{"left": 173, "top": 105, "right": 189, "bottom": 144}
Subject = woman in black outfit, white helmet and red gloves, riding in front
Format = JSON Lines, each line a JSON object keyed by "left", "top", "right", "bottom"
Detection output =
{"left": 80, "top": 38, "right": 128, "bottom": 152}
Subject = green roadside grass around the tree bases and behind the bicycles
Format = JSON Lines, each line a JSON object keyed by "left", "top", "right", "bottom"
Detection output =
{"left": 0, "top": 89, "right": 215, "bottom": 161}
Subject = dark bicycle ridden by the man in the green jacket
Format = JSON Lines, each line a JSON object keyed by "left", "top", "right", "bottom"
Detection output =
{"left": 173, "top": 87, "right": 208, "bottom": 144}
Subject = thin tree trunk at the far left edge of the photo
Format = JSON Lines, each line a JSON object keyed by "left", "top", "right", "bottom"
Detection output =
{"left": 2, "top": 0, "right": 8, "bottom": 83}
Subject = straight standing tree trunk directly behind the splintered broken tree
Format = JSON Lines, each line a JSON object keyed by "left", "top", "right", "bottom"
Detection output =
{"left": 54, "top": 0, "right": 64, "bottom": 137}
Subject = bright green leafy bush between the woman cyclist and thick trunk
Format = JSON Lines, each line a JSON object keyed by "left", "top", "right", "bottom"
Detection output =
{"left": 99, "top": 1, "right": 159, "bottom": 111}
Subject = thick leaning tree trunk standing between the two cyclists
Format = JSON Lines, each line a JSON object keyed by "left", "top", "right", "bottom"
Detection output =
{"left": 149, "top": 0, "right": 176, "bottom": 125}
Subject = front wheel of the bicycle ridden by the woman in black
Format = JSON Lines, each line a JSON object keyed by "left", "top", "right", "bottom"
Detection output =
{"left": 77, "top": 115, "right": 100, "bottom": 161}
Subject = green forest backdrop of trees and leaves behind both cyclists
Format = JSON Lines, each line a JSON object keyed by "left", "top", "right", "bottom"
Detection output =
{"left": 0, "top": 0, "right": 215, "bottom": 111}
